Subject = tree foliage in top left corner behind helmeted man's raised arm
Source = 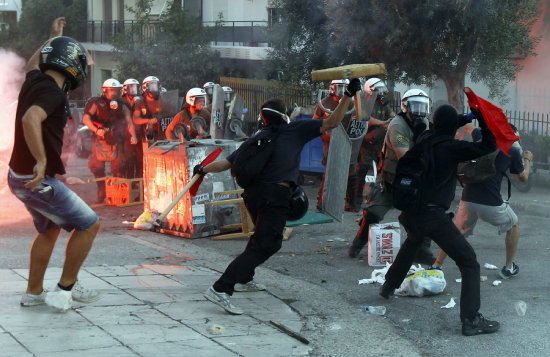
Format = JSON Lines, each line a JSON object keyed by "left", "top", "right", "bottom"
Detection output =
{"left": 0, "top": 0, "right": 87, "bottom": 58}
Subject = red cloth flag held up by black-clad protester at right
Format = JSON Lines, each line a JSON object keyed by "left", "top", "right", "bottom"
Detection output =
{"left": 464, "top": 87, "right": 519, "bottom": 156}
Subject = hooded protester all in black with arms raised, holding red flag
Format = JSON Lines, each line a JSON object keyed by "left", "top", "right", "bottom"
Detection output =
{"left": 380, "top": 105, "right": 499, "bottom": 336}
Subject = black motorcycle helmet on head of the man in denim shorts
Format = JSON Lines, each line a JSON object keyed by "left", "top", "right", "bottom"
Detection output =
{"left": 38, "top": 36, "right": 88, "bottom": 91}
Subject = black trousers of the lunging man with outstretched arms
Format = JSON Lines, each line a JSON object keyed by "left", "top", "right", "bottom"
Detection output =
{"left": 214, "top": 183, "right": 290, "bottom": 295}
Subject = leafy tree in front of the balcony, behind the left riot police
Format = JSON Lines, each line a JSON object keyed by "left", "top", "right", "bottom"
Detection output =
{"left": 113, "top": 0, "right": 222, "bottom": 90}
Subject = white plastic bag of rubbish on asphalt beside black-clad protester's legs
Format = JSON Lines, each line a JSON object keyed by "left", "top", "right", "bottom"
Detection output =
{"left": 395, "top": 270, "right": 447, "bottom": 296}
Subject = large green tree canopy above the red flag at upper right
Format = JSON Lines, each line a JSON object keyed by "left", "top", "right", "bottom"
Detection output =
{"left": 327, "top": 0, "right": 540, "bottom": 108}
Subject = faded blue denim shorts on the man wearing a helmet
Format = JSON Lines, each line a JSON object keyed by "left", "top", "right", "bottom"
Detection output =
{"left": 8, "top": 169, "right": 99, "bottom": 233}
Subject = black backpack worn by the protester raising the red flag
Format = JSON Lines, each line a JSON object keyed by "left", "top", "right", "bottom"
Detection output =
{"left": 392, "top": 137, "right": 449, "bottom": 212}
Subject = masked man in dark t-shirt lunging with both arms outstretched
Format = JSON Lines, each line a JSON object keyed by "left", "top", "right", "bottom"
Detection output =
{"left": 193, "top": 79, "right": 361, "bottom": 315}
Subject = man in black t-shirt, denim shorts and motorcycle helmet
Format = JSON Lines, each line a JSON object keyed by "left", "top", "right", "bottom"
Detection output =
{"left": 8, "top": 17, "right": 100, "bottom": 310}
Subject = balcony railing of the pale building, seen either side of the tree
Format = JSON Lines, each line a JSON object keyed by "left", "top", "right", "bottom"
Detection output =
{"left": 69, "top": 20, "right": 269, "bottom": 47}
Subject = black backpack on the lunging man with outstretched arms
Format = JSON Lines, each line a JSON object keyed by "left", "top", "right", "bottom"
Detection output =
{"left": 231, "top": 126, "right": 279, "bottom": 189}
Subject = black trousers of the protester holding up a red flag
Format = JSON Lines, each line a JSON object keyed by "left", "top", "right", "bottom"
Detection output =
{"left": 386, "top": 207, "right": 480, "bottom": 321}
